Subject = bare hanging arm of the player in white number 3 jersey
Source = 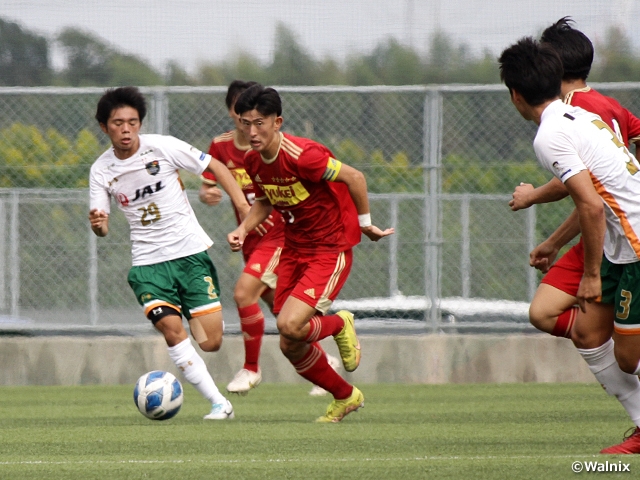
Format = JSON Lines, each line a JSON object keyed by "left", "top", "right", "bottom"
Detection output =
{"left": 565, "top": 170, "right": 606, "bottom": 312}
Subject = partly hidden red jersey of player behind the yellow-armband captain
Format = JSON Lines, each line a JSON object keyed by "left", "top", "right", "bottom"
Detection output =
{"left": 202, "top": 127, "right": 284, "bottom": 255}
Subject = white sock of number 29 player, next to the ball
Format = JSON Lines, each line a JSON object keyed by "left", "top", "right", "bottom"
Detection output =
{"left": 167, "top": 338, "right": 226, "bottom": 404}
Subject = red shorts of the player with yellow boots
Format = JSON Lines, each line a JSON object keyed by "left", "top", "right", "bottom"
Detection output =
{"left": 273, "top": 248, "right": 353, "bottom": 314}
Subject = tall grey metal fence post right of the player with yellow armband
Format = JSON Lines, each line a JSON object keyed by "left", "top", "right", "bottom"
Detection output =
{"left": 423, "top": 90, "right": 442, "bottom": 332}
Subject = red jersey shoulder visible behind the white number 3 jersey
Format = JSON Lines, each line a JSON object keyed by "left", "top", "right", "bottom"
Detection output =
{"left": 564, "top": 87, "right": 640, "bottom": 147}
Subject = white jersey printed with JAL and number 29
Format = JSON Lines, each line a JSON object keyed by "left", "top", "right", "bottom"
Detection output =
{"left": 89, "top": 135, "right": 213, "bottom": 266}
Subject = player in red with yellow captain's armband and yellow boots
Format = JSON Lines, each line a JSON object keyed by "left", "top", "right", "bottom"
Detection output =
{"left": 227, "top": 85, "right": 394, "bottom": 422}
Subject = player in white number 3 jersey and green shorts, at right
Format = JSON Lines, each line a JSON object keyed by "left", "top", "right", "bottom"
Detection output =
{"left": 499, "top": 37, "right": 640, "bottom": 453}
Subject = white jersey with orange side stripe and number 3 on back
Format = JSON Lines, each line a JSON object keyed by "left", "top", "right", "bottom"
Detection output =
{"left": 533, "top": 100, "right": 640, "bottom": 264}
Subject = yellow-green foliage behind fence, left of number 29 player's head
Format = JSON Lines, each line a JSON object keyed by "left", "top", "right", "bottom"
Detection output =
{"left": 0, "top": 123, "right": 102, "bottom": 188}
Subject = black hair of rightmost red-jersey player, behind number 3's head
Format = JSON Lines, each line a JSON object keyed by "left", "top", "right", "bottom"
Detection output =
{"left": 540, "top": 17, "right": 593, "bottom": 80}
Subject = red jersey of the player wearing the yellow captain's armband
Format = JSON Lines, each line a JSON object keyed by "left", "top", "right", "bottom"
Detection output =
{"left": 245, "top": 133, "right": 361, "bottom": 252}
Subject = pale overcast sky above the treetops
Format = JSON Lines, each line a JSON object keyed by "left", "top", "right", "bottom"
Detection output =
{"left": 0, "top": 0, "right": 640, "bottom": 72}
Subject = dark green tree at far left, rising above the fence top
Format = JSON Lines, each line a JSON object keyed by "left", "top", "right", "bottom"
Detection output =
{"left": 0, "top": 18, "right": 52, "bottom": 87}
